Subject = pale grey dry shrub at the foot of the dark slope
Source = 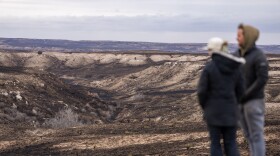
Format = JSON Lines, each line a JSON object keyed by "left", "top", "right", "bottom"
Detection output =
{"left": 44, "top": 108, "right": 83, "bottom": 128}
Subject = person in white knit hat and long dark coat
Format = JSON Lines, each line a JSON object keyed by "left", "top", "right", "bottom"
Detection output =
{"left": 197, "top": 37, "right": 245, "bottom": 156}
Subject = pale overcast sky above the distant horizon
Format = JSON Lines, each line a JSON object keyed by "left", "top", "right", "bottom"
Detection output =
{"left": 0, "top": 0, "right": 280, "bottom": 44}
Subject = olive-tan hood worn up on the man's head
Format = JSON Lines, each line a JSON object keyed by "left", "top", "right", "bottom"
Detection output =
{"left": 240, "top": 25, "right": 260, "bottom": 56}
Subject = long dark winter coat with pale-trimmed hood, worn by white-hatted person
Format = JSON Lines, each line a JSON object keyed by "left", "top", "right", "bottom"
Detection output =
{"left": 197, "top": 52, "right": 245, "bottom": 126}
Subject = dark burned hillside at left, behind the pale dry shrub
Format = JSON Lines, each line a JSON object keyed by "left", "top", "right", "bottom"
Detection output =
{"left": 0, "top": 66, "right": 119, "bottom": 126}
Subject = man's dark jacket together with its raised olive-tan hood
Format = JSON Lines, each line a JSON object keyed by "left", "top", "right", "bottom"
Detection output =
{"left": 234, "top": 25, "right": 268, "bottom": 104}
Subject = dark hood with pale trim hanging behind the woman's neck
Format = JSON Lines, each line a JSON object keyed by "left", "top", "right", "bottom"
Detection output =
{"left": 212, "top": 52, "right": 246, "bottom": 73}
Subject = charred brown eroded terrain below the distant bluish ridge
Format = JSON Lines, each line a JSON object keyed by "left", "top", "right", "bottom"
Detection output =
{"left": 0, "top": 52, "right": 280, "bottom": 156}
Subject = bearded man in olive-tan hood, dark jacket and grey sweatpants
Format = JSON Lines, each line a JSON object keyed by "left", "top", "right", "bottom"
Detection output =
{"left": 235, "top": 24, "right": 268, "bottom": 156}
